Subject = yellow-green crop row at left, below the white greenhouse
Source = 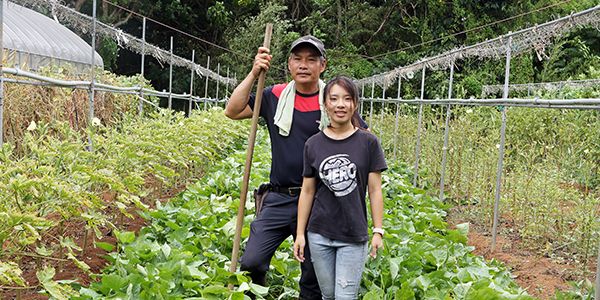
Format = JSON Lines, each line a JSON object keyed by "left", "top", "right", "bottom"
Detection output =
{"left": 0, "top": 110, "right": 247, "bottom": 299}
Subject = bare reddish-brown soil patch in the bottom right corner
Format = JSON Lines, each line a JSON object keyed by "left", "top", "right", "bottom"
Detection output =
{"left": 447, "top": 209, "right": 596, "bottom": 300}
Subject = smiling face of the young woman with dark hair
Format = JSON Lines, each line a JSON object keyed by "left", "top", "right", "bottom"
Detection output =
{"left": 325, "top": 84, "right": 356, "bottom": 127}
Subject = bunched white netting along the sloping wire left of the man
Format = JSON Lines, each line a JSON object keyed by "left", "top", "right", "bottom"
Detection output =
{"left": 11, "top": 0, "right": 237, "bottom": 86}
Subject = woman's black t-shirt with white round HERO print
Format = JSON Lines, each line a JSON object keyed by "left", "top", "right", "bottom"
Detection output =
{"left": 302, "top": 130, "right": 387, "bottom": 242}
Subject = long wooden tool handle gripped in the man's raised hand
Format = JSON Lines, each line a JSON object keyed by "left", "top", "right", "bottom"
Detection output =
{"left": 229, "top": 23, "right": 273, "bottom": 282}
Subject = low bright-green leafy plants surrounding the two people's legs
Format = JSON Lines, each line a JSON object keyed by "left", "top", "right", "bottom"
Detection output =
{"left": 70, "top": 125, "right": 533, "bottom": 299}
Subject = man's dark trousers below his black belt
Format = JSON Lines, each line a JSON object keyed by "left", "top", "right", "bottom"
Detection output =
{"left": 240, "top": 192, "right": 322, "bottom": 299}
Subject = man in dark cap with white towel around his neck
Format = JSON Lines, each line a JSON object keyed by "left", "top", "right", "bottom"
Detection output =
{"left": 225, "top": 35, "right": 327, "bottom": 299}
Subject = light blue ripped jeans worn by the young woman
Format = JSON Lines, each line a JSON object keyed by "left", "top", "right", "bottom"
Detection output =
{"left": 307, "top": 232, "right": 369, "bottom": 300}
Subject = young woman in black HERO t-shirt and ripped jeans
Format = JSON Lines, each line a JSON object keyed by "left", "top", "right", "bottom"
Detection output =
{"left": 294, "top": 77, "right": 387, "bottom": 300}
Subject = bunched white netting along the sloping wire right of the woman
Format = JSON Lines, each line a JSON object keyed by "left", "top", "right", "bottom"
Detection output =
{"left": 355, "top": 5, "right": 600, "bottom": 88}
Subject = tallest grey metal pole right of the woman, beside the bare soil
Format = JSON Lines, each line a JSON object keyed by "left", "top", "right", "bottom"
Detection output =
{"left": 491, "top": 38, "right": 512, "bottom": 252}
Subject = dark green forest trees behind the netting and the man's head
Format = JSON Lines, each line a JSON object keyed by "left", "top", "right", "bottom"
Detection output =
{"left": 65, "top": 0, "right": 600, "bottom": 109}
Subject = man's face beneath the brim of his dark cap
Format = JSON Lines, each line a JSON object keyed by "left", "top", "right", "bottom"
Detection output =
{"left": 288, "top": 44, "right": 326, "bottom": 84}
